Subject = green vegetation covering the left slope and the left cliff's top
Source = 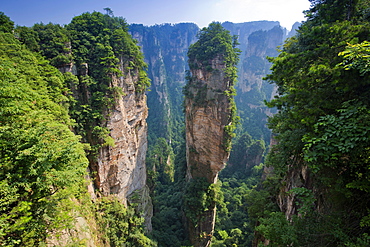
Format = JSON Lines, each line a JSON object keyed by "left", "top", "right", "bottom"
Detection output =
{"left": 0, "top": 12, "right": 155, "bottom": 246}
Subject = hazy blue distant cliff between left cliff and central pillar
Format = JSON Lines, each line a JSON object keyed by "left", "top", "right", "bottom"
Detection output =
{"left": 130, "top": 23, "right": 199, "bottom": 144}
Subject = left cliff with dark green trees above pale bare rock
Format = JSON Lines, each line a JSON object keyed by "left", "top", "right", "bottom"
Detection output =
{"left": 67, "top": 12, "right": 151, "bottom": 226}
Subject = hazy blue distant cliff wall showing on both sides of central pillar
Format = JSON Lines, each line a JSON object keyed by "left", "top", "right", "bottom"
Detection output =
{"left": 129, "top": 21, "right": 287, "bottom": 151}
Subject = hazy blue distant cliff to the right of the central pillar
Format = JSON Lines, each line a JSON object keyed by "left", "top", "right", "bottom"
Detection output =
{"left": 235, "top": 25, "right": 286, "bottom": 143}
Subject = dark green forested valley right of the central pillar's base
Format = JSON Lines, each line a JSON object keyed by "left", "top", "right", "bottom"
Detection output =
{"left": 212, "top": 133, "right": 267, "bottom": 246}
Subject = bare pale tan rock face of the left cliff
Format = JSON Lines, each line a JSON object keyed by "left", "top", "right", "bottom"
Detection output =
{"left": 93, "top": 62, "right": 153, "bottom": 231}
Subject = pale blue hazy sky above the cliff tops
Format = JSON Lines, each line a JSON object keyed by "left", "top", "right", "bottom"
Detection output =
{"left": 0, "top": 0, "right": 310, "bottom": 30}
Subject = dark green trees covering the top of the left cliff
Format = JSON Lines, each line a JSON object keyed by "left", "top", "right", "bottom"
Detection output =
{"left": 16, "top": 12, "right": 150, "bottom": 156}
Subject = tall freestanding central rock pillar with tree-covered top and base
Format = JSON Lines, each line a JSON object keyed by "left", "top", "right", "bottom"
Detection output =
{"left": 184, "top": 23, "right": 240, "bottom": 246}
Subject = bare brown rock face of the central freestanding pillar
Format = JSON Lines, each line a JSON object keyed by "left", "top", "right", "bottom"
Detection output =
{"left": 185, "top": 57, "right": 231, "bottom": 183}
